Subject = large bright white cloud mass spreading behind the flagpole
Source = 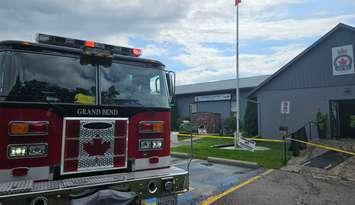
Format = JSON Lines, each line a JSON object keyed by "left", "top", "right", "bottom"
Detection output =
{"left": 154, "top": 0, "right": 355, "bottom": 84}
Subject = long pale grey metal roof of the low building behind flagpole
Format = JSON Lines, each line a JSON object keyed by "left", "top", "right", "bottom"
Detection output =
{"left": 175, "top": 75, "right": 269, "bottom": 95}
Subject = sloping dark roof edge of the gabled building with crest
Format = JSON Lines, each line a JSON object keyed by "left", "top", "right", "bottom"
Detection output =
{"left": 248, "top": 23, "right": 355, "bottom": 98}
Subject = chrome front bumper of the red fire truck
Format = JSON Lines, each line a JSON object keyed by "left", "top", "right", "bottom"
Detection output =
{"left": 0, "top": 167, "right": 188, "bottom": 202}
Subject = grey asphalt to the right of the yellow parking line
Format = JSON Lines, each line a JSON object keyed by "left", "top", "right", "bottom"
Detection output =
{"left": 213, "top": 170, "right": 355, "bottom": 205}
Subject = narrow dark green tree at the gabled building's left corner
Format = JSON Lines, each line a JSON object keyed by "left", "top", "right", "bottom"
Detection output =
{"left": 244, "top": 102, "right": 258, "bottom": 136}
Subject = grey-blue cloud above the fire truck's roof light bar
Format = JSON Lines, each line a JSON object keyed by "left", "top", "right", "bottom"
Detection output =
{"left": 0, "top": 0, "right": 189, "bottom": 41}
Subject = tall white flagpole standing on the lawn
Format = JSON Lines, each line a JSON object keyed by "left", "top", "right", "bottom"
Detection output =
{"left": 234, "top": 0, "right": 240, "bottom": 149}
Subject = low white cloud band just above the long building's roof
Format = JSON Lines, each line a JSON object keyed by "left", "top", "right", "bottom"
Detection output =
{"left": 177, "top": 44, "right": 305, "bottom": 85}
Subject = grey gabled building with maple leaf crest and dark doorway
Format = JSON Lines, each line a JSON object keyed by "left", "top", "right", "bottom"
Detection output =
{"left": 249, "top": 24, "right": 355, "bottom": 138}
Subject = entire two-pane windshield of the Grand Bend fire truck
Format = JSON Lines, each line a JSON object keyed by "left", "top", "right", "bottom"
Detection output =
{"left": 0, "top": 51, "right": 169, "bottom": 107}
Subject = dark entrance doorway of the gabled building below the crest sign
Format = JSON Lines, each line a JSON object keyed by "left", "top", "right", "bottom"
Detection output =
{"left": 339, "top": 100, "right": 355, "bottom": 138}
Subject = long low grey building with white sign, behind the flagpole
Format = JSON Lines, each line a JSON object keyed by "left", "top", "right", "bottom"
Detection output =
{"left": 176, "top": 76, "right": 268, "bottom": 125}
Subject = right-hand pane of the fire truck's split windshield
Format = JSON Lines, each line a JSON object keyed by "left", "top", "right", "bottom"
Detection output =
{"left": 99, "top": 62, "right": 169, "bottom": 107}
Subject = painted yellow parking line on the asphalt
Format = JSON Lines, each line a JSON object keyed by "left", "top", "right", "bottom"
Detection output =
{"left": 200, "top": 169, "right": 274, "bottom": 205}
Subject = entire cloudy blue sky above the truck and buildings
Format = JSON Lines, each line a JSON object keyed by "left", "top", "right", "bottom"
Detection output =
{"left": 0, "top": 0, "right": 355, "bottom": 85}
